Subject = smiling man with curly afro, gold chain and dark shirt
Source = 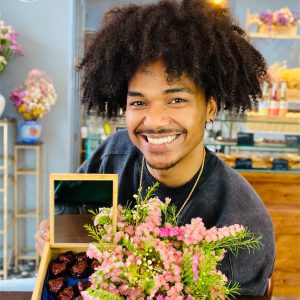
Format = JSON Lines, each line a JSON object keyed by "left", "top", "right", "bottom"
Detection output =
{"left": 36, "top": 0, "right": 274, "bottom": 296}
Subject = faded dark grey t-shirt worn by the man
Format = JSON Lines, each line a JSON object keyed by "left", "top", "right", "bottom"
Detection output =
{"left": 79, "top": 130, "right": 275, "bottom": 296}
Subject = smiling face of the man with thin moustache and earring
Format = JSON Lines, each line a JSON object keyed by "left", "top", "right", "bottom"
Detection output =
{"left": 126, "top": 61, "right": 217, "bottom": 170}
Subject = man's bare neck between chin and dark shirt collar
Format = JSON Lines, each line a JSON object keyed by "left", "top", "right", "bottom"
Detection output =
{"left": 147, "top": 145, "right": 204, "bottom": 188}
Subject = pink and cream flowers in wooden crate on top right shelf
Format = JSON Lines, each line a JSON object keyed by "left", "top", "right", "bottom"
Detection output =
{"left": 259, "top": 7, "right": 299, "bottom": 26}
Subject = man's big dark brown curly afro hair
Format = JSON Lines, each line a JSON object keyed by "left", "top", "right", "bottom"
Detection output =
{"left": 79, "top": 0, "right": 266, "bottom": 117}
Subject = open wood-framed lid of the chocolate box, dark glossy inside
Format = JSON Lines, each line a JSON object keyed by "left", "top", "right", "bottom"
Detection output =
{"left": 50, "top": 173, "right": 118, "bottom": 248}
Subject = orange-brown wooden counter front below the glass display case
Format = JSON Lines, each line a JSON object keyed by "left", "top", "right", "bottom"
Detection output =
{"left": 240, "top": 172, "right": 300, "bottom": 296}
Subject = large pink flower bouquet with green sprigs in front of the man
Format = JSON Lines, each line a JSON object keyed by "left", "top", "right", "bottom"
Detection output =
{"left": 82, "top": 183, "right": 261, "bottom": 300}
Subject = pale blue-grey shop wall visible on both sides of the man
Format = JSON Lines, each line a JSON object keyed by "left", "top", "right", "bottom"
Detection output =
{"left": 0, "top": 0, "right": 300, "bottom": 256}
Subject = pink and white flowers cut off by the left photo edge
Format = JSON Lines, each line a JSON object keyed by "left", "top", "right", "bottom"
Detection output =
{"left": 0, "top": 20, "right": 25, "bottom": 75}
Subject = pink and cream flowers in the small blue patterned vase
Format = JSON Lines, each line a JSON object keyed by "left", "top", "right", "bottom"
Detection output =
{"left": 10, "top": 70, "right": 57, "bottom": 120}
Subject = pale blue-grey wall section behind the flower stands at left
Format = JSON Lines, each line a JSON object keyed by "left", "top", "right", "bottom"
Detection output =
{"left": 0, "top": 0, "right": 78, "bottom": 255}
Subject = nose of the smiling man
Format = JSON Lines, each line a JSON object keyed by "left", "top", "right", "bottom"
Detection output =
{"left": 144, "top": 104, "right": 170, "bottom": 129}
